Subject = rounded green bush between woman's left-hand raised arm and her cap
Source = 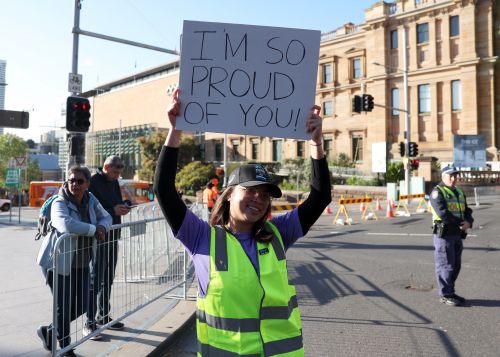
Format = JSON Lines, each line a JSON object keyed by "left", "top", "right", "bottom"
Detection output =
{"left": 175, "top": 161, "right": 215, "bottom": 195}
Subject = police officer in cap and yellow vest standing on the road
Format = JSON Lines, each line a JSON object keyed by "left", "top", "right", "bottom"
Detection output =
{"left": 430, "top": 166, "right": 474, "bottom": 306}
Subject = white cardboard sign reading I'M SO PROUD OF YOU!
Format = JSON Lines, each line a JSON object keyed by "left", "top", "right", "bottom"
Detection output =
{"left": 176, "top": 21, "right": 321, "bottom": 139}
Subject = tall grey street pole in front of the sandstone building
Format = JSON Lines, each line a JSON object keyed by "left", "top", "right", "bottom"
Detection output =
{"left": 372, "top": 28, "right": 411, "bottom": 195}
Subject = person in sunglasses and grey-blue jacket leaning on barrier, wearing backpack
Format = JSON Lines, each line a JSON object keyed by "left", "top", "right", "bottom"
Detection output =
{"left": 37, "top": 167, "right": 111, "bottom": 356}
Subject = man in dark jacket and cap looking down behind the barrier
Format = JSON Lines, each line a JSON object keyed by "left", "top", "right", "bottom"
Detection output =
{"left": 84, "top": 155, "right": 130, "bottom": 339}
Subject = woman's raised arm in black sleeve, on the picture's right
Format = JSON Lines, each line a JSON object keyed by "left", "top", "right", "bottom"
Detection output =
{"left": 298, "top": 105, "right": 332, "bottom": 235}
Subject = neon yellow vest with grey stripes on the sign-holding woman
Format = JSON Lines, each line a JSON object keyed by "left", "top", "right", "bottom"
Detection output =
{"left": 196, "top": 222, "right": 304, "bottom": 357}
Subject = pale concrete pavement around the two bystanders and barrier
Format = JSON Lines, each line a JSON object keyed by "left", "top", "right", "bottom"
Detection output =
{"left": 0, "top": 208, "right": 195, "bottom": 357}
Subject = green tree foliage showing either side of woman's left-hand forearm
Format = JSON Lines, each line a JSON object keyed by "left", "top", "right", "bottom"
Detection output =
{"left": 138, "top": 131, "right": 197, "bottom": 181}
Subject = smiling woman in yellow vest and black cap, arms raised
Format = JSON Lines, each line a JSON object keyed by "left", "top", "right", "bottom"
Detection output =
{"left": 155, "top": 91, "right": 331, "bottom": 356}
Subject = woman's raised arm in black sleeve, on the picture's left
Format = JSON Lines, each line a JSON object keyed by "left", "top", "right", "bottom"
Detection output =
{"left": 154, "top": 89, "right": 187, "bottom": 232}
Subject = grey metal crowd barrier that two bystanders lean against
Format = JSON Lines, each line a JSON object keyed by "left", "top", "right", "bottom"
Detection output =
{"left": 49, "top": 204, "right": 203, "bottom": 356}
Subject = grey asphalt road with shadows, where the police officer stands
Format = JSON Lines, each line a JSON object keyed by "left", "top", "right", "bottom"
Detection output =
{"left": 160, "top": 197, "right": 500, "bottom": 357}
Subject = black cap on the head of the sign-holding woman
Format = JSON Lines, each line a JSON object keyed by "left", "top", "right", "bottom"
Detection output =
{"left": 227, "top": 164, "right": 281, "bottom": 198}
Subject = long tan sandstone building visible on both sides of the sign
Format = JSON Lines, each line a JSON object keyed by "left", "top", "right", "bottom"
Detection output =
{"left": 84, "top": 0, "right": 500, "bottom": 173}
